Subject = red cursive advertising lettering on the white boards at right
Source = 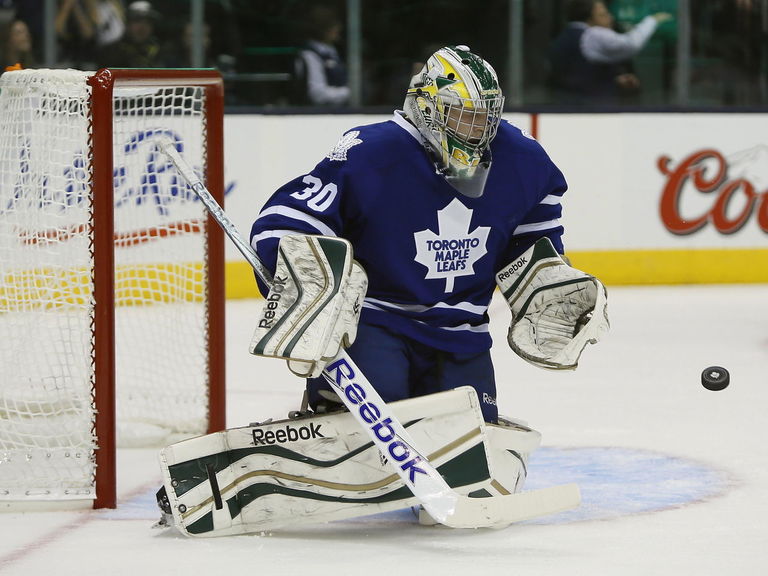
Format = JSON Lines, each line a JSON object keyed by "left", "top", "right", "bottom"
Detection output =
{"left": 657, "top": 146, "right": 768, "bottom": 235}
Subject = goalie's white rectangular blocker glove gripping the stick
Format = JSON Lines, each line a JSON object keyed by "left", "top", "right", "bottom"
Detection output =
{"left": 250, "top": 234, "right": 368, "bottom": 378}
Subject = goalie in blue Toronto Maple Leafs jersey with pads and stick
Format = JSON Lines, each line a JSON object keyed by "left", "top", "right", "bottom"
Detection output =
{"left": 158, "top": 46, "right": 608, "bottom": 536}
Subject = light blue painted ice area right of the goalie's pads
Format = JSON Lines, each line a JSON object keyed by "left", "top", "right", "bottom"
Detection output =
{"left": 524, "top": 447, "right": 732, "bottom": 524}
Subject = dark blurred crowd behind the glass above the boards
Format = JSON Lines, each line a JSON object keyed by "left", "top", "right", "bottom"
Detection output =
{"left": 0, "top": 0, "right": 768, "bottom": 111}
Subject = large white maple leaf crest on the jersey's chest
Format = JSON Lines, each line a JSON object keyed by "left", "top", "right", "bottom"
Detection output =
{"left": 413, "top": 198, "right": 490, "bottom": 292}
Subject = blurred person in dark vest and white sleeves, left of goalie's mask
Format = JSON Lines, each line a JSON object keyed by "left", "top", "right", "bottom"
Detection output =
{"left": 294, "top": 5, "right": 349, "bottom": 106}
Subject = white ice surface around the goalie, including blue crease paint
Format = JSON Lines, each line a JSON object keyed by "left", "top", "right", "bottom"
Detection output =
{"left": 0, "top": 285, "right": 768, "bottom": 576}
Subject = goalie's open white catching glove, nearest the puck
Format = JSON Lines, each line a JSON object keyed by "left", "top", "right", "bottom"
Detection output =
{"left": 496, "top": 238, "right": 609, "bottom": 370}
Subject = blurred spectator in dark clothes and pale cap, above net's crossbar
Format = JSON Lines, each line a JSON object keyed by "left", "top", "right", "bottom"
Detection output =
{"left": 99, "top": 0, "right": 161, "bottom": 68}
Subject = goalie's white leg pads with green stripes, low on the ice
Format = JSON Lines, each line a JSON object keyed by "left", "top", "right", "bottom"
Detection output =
{"left": 160, "top": 387, "right": 546, "bottom": 537}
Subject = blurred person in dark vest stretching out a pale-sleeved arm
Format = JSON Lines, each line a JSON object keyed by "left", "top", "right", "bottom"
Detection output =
{"left": 550, "top": 0, "right": 672, "bottom": 104}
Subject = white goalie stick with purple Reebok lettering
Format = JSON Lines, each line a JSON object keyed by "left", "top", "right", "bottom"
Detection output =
{"left": 158, "top": 135, "right": 581, "bottom": 528}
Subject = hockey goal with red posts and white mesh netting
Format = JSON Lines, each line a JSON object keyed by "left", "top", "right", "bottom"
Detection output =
{"left": 0, "top": 70, "right": 224, "bottom": 507}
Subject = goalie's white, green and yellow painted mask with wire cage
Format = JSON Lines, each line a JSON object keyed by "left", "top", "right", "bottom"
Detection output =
{"left": 403, "top": 46, "right": 504, "bottom": 198}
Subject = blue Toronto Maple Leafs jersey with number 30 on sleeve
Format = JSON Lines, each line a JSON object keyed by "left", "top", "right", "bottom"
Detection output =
{"left": 251, "top": 112, "right": 567, "bottom": 354}
